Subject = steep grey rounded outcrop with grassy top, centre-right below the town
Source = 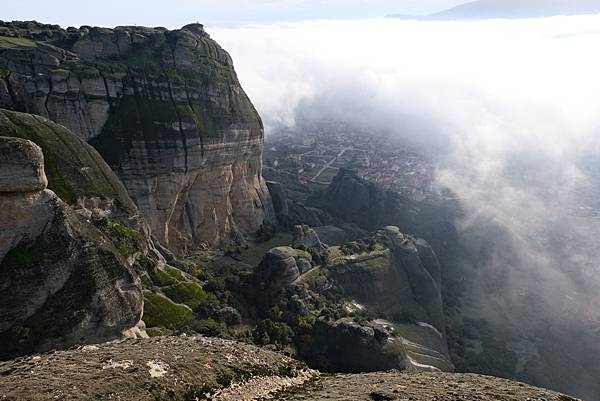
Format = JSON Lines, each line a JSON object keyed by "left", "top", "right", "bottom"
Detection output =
{"left": 327, "top": 227, "right": 445, "bottom": 333}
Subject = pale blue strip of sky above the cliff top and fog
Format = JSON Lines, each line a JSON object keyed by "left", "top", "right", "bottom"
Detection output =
{"left": 0, "top": 0, "right": 466, "bottom": 28}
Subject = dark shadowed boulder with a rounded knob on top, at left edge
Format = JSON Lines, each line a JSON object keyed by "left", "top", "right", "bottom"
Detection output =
{"left": 0, "top": 137, "right": 142, "bottom": 358}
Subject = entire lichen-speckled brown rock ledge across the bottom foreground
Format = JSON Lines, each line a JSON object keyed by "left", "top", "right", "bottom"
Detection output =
{"left": 0, "top": 337, "right": 575, "bottom": 401}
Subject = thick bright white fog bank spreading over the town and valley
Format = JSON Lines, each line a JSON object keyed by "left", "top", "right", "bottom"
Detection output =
{"left": 209, "top": 15, "right": 600, "bottom": 395}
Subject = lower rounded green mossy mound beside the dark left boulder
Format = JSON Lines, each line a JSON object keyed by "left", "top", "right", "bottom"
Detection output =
{"left": 143, "top": 291, "right": 194, "bottom": 330}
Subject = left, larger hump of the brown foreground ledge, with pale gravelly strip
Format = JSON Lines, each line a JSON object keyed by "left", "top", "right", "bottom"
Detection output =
{"left": 0, "top": 337, "right": 319, "bottom": 401}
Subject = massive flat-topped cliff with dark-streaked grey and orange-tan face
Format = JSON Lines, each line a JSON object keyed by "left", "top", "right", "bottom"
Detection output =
{"left": 0, "top": 23, "right": 273, "bottom": 253}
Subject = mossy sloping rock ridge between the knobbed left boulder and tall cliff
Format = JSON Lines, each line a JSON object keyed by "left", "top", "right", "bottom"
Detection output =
{"left": 0, "top": 109, "right": 164, "bottom": 272}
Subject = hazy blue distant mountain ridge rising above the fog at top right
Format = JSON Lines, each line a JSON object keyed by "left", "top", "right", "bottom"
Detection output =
{"left": 389, "top": 0, "right": 600, "bottom": 20}
